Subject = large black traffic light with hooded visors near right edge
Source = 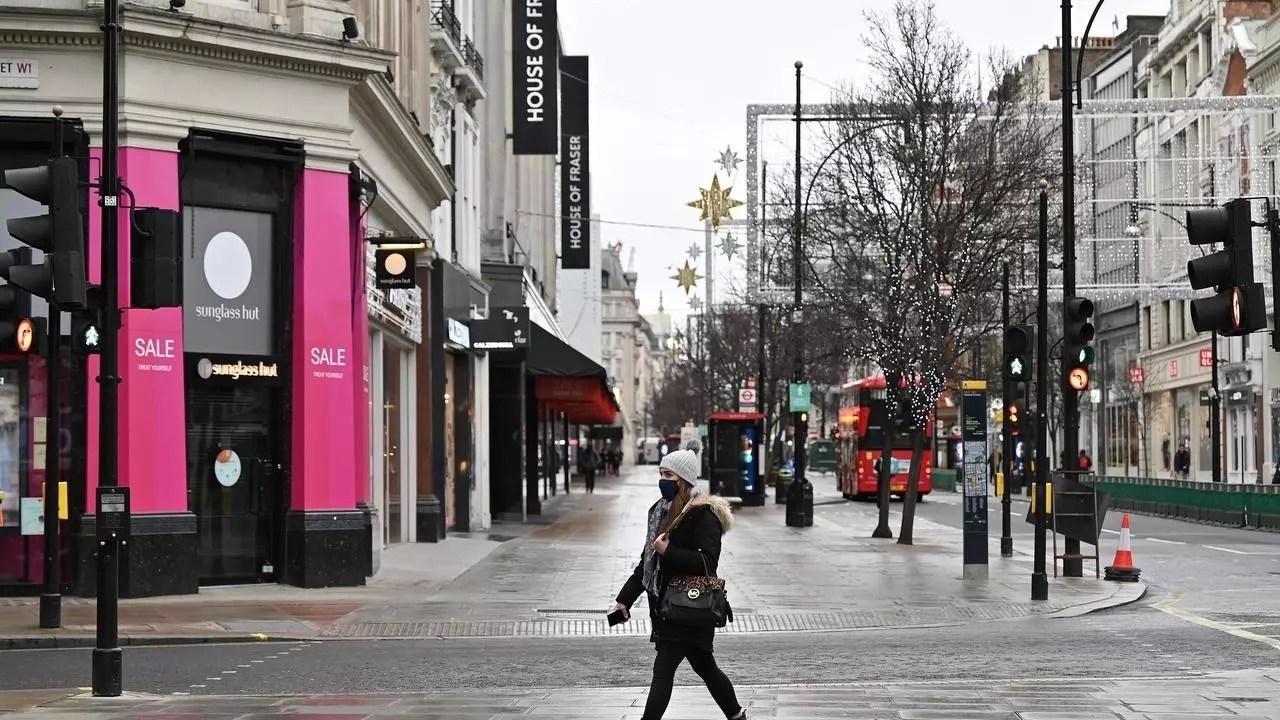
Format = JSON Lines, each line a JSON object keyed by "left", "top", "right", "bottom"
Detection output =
{"left": 1187, "top": 199, "right": 1267, "bottom": 336}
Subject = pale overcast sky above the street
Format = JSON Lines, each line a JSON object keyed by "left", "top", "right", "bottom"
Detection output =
{"left": 559, "top": 0, "right": 1170, "bottom": 313}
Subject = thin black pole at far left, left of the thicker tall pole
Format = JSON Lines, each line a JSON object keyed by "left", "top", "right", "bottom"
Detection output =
{"left": 40, "top": 106, "right": 65, "bottom": 629}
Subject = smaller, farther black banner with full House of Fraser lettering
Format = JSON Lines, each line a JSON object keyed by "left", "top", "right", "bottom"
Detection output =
{"left": 561, "top": 55, "right": 591, "bottom": 270}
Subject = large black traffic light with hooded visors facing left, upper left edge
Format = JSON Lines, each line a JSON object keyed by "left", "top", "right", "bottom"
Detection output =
{"left": 4, "top": 158, "right": 84, "bottom": 310}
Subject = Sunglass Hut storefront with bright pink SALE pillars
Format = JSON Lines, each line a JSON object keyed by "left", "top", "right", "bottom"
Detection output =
{"left": 0, "top": 119, "right": 370, "bottom": 597}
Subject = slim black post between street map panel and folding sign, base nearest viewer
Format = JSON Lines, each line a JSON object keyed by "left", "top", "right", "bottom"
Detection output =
{"left": 1023, "top": 185, "right": 1049, "bottom": 600}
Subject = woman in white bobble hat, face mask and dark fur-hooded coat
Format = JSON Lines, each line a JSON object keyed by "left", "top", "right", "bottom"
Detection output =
{"left": 614, "top": 450, "right": 746, "bottom": 720}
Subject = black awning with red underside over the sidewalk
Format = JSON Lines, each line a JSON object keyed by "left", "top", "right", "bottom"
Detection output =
{"left": 525, "top": 324, "right": 618, "bottom": 425}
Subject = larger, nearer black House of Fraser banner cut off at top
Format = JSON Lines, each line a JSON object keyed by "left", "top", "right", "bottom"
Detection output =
{"left": 511, "top": 0, "right": 559, "bottom": 155}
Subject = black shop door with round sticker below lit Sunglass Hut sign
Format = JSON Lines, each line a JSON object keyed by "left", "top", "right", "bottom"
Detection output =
{"left": 187, "top": 384, "right": 288, "bottom": 585}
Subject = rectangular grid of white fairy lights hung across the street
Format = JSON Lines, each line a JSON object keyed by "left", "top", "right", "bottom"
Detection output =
{"left": 745, "top": 96, "right": 1280, "bottom": 302}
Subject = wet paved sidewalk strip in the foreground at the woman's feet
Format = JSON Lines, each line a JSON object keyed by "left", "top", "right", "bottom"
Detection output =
{"left": 6, "top": 671, "right": 1280, "bottom": 720}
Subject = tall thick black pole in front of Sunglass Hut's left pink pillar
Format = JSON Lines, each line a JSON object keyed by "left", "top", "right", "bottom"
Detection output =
{"left": 92, "top": 0, "right": 124, "bottom": 697}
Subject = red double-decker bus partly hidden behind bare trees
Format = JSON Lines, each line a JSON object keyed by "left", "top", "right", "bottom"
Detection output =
{"left": 837, "top": 375, "right": 933, "bottom": 500}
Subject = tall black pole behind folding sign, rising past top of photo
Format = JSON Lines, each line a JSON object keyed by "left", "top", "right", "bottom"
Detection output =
{"left": 1059, "top": 0, "right": 1084, "bottom": 576}
